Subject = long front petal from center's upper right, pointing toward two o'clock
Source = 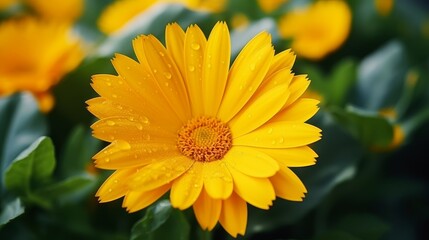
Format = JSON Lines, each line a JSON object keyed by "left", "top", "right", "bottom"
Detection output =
{"left": 229, "top": 79, "right": 289, "bottom": 137}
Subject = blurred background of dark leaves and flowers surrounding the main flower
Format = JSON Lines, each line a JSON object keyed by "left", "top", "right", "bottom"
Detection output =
{"left": 0, "top": 0, "right": 429, "bottom": 240}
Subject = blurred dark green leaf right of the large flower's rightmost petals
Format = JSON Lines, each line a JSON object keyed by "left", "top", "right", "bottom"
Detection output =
{"left": 332, "top": 106, "right": 393, "bottom": 147}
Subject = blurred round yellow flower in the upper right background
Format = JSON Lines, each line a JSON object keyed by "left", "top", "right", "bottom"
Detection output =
{"left": 279, "top": 0, "right": 351, "bottom": 60}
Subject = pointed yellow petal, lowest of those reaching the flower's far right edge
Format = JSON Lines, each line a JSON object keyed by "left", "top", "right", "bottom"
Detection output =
{"left": 258, "top": 146, "right": 318, "bottom": 167}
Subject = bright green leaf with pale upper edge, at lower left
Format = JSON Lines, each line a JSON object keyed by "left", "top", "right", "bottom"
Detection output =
{"left": 4, "top": 137, "right": 55, "bottom": 195}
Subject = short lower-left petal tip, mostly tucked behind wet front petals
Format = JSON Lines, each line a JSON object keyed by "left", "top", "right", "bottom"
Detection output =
{"left": 95, "top": 168, "right": 136, "bottom": 202}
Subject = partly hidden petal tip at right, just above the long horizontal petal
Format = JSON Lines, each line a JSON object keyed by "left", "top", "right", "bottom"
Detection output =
{"left": 270, "top": 98, "right": 320, "bottom": 122}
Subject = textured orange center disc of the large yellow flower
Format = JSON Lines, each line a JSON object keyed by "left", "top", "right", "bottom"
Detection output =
{"left": 177, "top": 117, "right": 232, "bottom": 162}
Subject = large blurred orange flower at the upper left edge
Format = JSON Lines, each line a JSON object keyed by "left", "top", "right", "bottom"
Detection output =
{"left": 0, "top": 18, "right": 83, "bottom": 112}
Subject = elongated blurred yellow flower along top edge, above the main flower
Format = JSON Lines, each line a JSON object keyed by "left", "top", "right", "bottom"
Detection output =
{"left": 98, "top": 0, "right": 227, "bottom": 34}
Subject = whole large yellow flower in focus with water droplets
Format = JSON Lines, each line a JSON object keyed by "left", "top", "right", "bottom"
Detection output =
{"left": 87, "top": 22, "right": 321, "bottom": 236}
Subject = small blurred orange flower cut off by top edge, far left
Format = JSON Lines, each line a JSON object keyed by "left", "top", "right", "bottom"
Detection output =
{"left": 24, "top": 0, "right": 84, "bottom": 22}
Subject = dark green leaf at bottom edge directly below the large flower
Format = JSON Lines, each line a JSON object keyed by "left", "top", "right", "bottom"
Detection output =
{"left": 131, "top": 200, "right": 190, "bottom": 240}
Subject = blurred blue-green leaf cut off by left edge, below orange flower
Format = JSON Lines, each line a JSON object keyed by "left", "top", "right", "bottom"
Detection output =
{"left": 0, "top": 93, "right": 47, "bottom": 189}
